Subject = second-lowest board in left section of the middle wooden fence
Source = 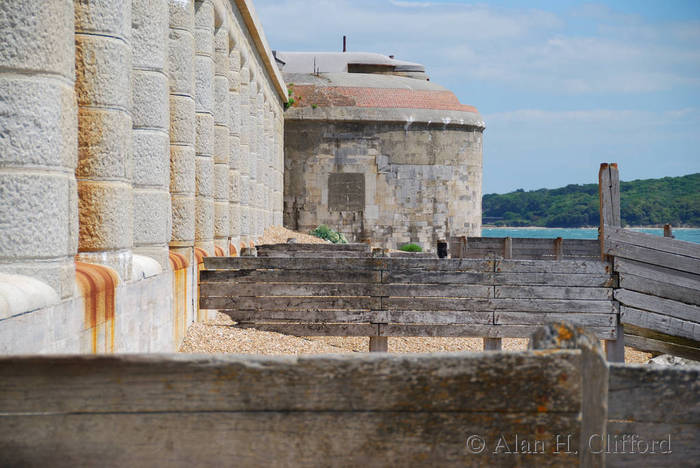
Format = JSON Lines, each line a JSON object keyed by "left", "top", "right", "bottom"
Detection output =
{"left": 221, "top": 309, "right": 383, "bottom": 324}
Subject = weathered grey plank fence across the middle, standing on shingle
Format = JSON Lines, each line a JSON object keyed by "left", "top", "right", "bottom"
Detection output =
{"left": 200, "top": 257, "right": 618, "bottom": 350}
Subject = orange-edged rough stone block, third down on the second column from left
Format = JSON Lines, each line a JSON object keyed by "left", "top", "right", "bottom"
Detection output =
{"left": 75, "top": 107, "right": 132, "bottom": 180}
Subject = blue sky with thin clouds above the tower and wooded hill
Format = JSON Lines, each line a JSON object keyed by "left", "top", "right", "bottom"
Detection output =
{"left": 254, "top": 0, "right": 700, "bottom": 194}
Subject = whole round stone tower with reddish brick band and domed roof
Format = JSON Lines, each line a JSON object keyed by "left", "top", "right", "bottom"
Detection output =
{"left": 276, "top": 52, "right": 484, "bottom": 251}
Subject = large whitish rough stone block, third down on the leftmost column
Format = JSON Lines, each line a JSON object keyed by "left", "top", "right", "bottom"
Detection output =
{"left": 0, "top": 170, "right": 73, "bottom": 261}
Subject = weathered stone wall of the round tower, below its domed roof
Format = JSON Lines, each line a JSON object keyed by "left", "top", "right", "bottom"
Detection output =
{"left": 284, "top": 103, "right": 484, "bottom": 251}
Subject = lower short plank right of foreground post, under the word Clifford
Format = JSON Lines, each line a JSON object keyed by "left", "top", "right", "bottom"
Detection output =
{"left": 604, "top": 421, "right": 700, "bottom": 468}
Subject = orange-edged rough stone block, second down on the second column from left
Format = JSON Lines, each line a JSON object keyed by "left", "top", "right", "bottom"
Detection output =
{"left": 75, "top": 34, "right": 131, "bottom": 110}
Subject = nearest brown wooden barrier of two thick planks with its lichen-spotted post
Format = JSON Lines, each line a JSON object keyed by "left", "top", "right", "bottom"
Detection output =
{"left": 0, "top": 324, "right": 607, "bottom": 467}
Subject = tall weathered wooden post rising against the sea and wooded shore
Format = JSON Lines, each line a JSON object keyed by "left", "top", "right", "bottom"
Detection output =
{"left": 598, "top": 163, "right": 625, "bottom": 362}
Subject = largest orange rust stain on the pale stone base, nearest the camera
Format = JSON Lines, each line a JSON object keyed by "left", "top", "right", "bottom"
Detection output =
{"left": 75, "top": 262, "right": 119, "bottom": 353}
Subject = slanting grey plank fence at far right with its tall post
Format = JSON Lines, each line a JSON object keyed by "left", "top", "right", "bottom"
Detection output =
{"left": 600, "top": 165, "right": 700, "bottom": 360}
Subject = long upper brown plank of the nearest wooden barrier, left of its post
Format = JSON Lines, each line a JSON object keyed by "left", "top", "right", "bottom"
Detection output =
{"left": 0, "top": 352, "right": 581, "bottom": 415}
